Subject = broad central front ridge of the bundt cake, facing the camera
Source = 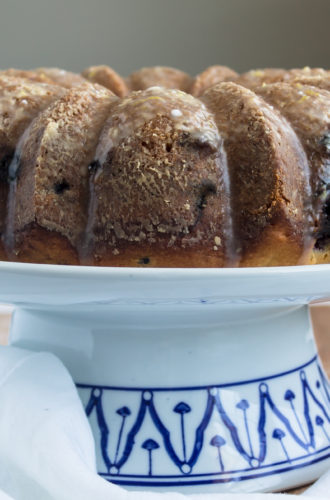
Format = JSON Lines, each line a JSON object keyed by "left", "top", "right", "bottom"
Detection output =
{"left": 86, "top": 88, "right": 235, "bottom": 267}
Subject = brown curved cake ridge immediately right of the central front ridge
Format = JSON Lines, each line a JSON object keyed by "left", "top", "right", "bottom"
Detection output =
{"left": 201, "top": 83, "right": 311, "bottom": 266}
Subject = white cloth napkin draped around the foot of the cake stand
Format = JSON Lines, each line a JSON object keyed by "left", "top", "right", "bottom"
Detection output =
{"left": 0, "top": 347, "right": 330, "bottom": 500}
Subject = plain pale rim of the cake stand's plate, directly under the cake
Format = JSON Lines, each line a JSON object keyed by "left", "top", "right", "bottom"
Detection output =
{"left": 0, "top": 262, "right": 330, "bottom": 307}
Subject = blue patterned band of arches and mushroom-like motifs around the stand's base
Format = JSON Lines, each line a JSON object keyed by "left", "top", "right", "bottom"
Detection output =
{"left": 77, "top": 356, "right": 330, "bottom": 486}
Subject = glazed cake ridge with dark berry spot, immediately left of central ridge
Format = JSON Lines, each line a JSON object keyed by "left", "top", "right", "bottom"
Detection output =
{"left": 5, "top": 82, "right": 116, "bottom": 260}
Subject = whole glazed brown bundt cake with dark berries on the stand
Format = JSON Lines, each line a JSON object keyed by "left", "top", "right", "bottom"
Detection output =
{"left": 0, "top": 66, "right": 330, "bottom": 267}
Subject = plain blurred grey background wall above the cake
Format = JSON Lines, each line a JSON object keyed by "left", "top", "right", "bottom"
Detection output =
{"left": 0, "top": 0, "right": 330, "bottom": 76}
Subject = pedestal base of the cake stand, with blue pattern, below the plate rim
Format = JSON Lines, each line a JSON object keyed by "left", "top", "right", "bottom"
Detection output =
{"left": 10, "top": 301, "right": 330, "bottom": 493}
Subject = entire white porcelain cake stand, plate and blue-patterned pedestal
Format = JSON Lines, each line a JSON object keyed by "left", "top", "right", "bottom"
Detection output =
{"left": 0, "top": 262, "right": 330, "bottom": 493}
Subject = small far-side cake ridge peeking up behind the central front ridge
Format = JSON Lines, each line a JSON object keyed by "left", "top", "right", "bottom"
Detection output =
{"left": 127, "top": 66, "right": 192, "bottom": 92}
